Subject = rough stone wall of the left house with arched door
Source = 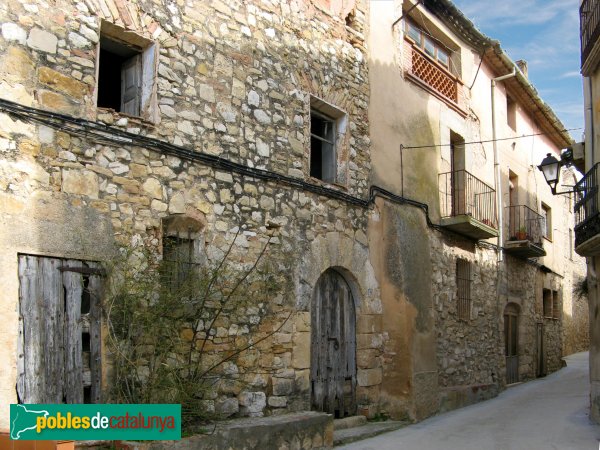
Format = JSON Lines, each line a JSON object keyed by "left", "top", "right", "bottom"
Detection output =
{"left": 0, "top": 0, "right": 382, "bottom": 426}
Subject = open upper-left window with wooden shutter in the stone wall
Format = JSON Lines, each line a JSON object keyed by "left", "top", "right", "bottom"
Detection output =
{"left": 97, "top": 23, "right": 156, "bottom": 120}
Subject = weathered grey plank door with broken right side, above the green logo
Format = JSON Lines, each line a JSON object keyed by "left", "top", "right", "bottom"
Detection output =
{"left": 17, "top": 255, "right": 101, "bottom": 403}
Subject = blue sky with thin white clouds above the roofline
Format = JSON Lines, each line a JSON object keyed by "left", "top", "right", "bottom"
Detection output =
{"left": 454, "top": 0, "right": 583, "bottom": 141}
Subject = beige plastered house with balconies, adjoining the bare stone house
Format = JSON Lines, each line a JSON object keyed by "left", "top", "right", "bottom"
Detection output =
{"left": 367, "top": 0, "right": 587, "bottom": 419}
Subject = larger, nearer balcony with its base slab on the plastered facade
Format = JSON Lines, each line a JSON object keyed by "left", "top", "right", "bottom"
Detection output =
{"left": 439, "top": 170, "right": 498, "bottom": 240}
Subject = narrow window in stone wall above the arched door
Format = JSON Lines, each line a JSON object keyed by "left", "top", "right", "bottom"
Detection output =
{"left": 310, "top": 97, "right": 346, "bottom": 183}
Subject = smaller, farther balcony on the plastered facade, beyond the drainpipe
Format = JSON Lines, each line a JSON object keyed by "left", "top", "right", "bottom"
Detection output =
{"left": 504, "top": 205, "right": 546, "bottom": 258}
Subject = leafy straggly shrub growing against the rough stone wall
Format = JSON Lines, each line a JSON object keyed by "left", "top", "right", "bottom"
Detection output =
{"left": 103, "top": 232, "right": 291, "bottom": 434}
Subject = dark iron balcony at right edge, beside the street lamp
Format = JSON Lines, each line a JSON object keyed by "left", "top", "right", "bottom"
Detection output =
{"left": 574, "top": 163, "right": 600, "bottom": 256}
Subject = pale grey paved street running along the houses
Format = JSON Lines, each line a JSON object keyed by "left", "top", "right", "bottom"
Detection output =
{"left": 338, "top": 353, "right": 600, "bottom": 450}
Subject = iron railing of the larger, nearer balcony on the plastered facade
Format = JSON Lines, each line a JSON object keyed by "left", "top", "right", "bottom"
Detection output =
{"left": 439, "top": 170, "right": 498, "bottom": 229}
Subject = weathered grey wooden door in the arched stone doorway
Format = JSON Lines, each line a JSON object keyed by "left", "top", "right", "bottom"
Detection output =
{"left": 310, "top": 269, "right": 356, "bottom": 417}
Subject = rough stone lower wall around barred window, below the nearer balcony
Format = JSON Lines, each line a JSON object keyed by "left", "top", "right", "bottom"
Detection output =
{"left": 431, "top": 236, "right": 501, "bottom": 409}
